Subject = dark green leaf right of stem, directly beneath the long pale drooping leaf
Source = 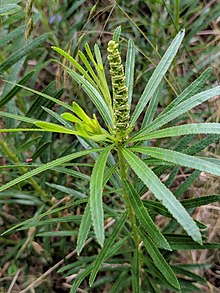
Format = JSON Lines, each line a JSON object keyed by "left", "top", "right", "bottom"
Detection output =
{"left": 124, "top": 181, "right": 170, "bottom": 250}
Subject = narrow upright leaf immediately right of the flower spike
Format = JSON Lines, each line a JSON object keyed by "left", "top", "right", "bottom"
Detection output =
{"left": 125, "top": 39, "right": 135, "bottom": 105}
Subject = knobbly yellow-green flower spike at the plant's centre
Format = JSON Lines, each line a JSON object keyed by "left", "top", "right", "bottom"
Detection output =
{"left": 107, "top": 40, "right": 130, "bottom": 141}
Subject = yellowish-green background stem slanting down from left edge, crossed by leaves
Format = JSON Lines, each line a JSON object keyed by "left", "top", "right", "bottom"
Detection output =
{"left": 0, "top": 140, "right": 48, "bottom": 200}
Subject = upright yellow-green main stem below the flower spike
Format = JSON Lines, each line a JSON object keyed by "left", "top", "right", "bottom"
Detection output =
{"left": 117, "top": 148, "right": 139, "bottom": 247}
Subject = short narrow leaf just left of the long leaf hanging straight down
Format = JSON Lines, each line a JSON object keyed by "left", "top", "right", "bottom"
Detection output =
{"left": 76, "top": 202, "right": 92, "bottom": 255}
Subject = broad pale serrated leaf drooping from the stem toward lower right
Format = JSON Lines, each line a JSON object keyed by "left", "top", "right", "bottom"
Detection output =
{"left": 122, "top": 149, "right": 202, "bottom": 243}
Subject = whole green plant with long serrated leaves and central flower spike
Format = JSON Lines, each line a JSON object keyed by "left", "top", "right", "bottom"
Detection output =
{"left": 0, "top": 28, "right": 220, "bottom": 292}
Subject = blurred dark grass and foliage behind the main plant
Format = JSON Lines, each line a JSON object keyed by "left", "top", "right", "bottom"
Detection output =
{"left": 0, "top": 0, "right": 220, "bottom": 292}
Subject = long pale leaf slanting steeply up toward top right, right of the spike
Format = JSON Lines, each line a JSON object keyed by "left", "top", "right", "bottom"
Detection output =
{"left": 130, "top": 30, "right": 185, "bottom": 126}
